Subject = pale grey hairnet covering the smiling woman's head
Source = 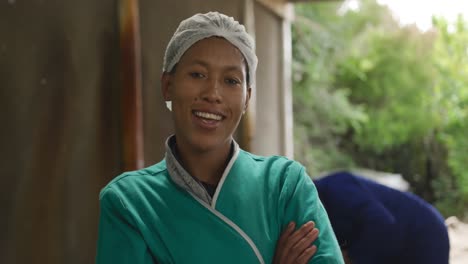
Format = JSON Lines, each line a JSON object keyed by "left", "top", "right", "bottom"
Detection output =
{"left": 163, "top": 12, "right": 258, "bottom": 87}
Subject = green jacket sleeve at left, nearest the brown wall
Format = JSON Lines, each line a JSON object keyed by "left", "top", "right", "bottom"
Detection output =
{"left": 96, "top": 187, "right": 155, "bottom": 264}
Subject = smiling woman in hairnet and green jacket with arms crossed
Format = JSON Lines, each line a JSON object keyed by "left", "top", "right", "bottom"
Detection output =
{"left": 97, "top": 12, "right": 343, "bottom": 264}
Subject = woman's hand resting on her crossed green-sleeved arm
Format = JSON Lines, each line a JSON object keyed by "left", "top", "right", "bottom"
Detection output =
{"left": 273, "top": 222, "right": 319, "bottom": 264}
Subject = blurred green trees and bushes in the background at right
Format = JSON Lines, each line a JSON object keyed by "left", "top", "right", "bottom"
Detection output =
{"left": 292, "top": 0, "right": 468, "bottom": 220}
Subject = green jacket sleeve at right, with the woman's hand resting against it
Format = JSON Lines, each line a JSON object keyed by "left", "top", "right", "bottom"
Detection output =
{"left": 280, "top": 163, "right": 344, "bottom": 264}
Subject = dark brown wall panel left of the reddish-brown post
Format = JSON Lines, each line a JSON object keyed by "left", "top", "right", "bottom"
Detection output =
{"left": 0, "top": 0, "right": 122, "bottom": 264}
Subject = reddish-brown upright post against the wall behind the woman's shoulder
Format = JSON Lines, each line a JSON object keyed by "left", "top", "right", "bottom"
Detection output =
{"left": 119, "top": 0, "right": 144, "bottom": 171}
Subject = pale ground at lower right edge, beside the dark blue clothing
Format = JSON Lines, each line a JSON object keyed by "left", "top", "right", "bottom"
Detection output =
{"left": 445, "top": 216, "right": 468, "bottom": 264}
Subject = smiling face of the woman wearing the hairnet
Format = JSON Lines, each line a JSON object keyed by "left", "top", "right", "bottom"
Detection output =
{"left": 162, "top": 37, "right": 250, "bottom": 154}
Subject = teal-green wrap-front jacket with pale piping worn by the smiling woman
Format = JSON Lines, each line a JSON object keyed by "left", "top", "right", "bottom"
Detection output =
{"left": 96, "top": 137, "right": 343, "bottom": 264}
